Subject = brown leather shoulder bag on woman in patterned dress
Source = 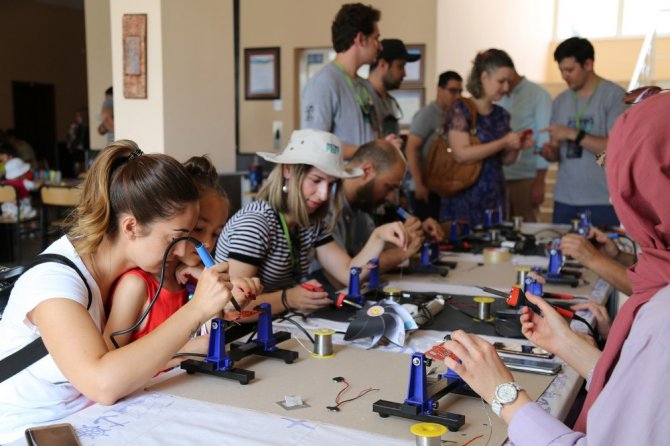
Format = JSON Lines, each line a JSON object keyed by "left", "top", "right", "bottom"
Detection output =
{"left": 423, "top": 98, "right": 483, "bottom": 197}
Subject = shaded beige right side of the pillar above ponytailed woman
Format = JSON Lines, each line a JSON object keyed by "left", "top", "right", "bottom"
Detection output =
{"left": 162, "top": 0, "right": 235, "bottom": 172}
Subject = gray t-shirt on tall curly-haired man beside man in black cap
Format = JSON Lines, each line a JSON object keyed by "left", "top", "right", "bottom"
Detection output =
{"left": 300, "top": 63, "right": 376, "bottom": 146}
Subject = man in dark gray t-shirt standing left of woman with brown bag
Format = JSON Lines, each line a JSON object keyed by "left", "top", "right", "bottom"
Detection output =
{"left": 405, "top": 71, "right": 463, "bottom": 220}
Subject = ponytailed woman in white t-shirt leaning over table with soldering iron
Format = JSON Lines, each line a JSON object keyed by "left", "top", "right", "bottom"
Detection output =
{"left": 0, "top": 140, "right": 254, "bottom": 444}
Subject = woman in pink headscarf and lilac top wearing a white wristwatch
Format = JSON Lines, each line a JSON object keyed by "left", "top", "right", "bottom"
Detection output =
{"left": 445, "top": 89, "right": 670, "bottom": 446}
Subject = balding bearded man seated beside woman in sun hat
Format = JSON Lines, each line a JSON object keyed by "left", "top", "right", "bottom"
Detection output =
{"left": 311, "top": 139, "right": 443, "bottom": 289}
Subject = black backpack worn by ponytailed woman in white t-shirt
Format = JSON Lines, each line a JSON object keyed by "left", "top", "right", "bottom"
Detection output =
{"left": 0, "top": 254, "right": 93, "bottom": 382}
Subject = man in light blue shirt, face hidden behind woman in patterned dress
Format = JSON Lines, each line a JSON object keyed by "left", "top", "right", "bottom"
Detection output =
{"left": 498, "top": 69, "right": 551, "bottom": 222}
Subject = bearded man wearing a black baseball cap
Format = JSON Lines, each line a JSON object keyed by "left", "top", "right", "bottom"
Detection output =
{"left": 366, "top": 39, "right": 421, "bottom": 139}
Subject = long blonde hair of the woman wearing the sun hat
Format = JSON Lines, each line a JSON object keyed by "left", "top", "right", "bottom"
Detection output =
{"left": 256, "top": 164, "right": 342, "bottom": 228}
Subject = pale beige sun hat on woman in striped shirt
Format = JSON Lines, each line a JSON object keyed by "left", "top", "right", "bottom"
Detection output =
{"left": 258, "top": 129, "right": 363, "bottom": 178}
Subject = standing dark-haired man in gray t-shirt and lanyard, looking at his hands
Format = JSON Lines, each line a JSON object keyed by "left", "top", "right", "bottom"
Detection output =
{"left": 543, "top": 37, "right": 625, "bottom": 226}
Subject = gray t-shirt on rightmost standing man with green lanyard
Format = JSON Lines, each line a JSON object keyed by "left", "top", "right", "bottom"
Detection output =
{"left": 551, "top": 79, "right": 626, "bottom": 206}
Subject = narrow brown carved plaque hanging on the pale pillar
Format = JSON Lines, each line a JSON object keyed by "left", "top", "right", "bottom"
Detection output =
{"left": 123, "top": 14, "right": 147, "bottom": 99}
